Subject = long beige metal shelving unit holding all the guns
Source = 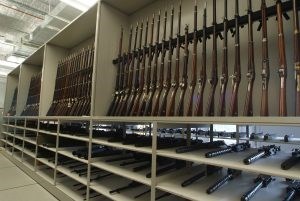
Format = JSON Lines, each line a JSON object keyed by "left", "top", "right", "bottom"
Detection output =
{"left": 1, "top": 0, "right": 300, "bottom": 201}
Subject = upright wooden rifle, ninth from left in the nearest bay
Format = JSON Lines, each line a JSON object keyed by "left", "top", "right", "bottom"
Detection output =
{"left": 158, "top": 7, "right": 174, "bottom": 116}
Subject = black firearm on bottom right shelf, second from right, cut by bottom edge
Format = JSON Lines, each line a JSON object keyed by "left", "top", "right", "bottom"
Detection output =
{"left": 241, "top": 176, "right": 273, "bottom": 201}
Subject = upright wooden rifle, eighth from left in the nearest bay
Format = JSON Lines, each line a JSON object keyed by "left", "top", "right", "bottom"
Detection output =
{"left": 151, "top": 11, "right": 168, "bottom": 116}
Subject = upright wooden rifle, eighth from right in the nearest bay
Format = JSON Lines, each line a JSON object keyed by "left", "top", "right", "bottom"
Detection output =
{"left": 195, "top": 3, "right": 207, "bottom": 116}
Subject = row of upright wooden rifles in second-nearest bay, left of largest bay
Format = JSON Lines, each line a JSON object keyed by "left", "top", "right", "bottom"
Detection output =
{"left": 47, "top": 47, "right": 94, "bottom": 116}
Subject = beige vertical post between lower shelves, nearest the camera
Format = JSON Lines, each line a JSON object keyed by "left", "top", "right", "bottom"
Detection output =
{"left": 150, "top": 121, "right": 158, "bottom": 201}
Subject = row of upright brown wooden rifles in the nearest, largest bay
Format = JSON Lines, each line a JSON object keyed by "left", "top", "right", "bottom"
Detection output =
{"left": 107, "top": 0, "right": 300, "bottom": 116}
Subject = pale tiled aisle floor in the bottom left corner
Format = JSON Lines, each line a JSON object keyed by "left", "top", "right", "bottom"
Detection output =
{"left": 0, "top": 150, "right": 57, "bottom": 201}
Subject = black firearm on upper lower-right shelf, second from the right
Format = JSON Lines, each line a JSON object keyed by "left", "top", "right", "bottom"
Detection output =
{"left": 244, "top": 145, "right": 280, "bottom": 165}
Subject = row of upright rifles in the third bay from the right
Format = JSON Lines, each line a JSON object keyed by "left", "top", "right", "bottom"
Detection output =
{"left": 21, "top": 73, "right": 42, "bottom": 116}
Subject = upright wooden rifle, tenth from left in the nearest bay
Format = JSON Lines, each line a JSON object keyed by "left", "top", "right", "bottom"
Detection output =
{"left": 167, "top": 1, "right": 182, "bottom": 116}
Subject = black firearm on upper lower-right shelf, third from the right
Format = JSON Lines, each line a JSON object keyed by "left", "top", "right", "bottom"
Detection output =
{"left": 205, "top": 142, "right": 250, "bottom": 158}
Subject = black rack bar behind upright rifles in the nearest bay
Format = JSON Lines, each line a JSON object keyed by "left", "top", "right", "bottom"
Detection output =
{"left": 113, "top": 1, "right": 300, "bottom": 64}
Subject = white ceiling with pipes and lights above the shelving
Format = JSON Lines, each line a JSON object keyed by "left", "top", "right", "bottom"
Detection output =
{"left": 0, "top": 0, "right": 97, "bottom": 77}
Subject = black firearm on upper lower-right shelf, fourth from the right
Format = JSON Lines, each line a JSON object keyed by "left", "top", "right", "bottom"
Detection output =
{"left": 175, "top": 140, "right": 225, "bottom": 153}
